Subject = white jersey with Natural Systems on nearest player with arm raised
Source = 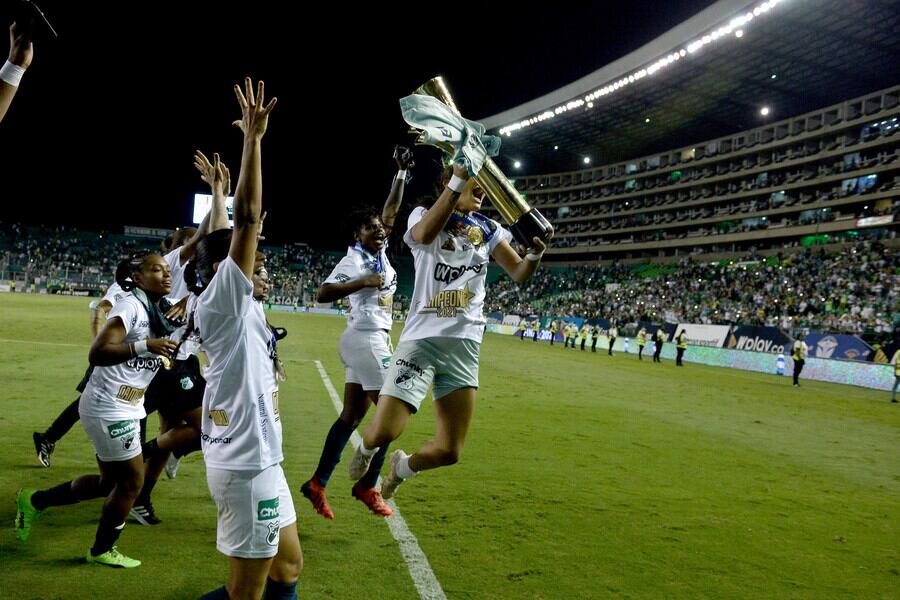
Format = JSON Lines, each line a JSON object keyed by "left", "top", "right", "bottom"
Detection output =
{"left": 194, "top": 256, "right": 283, "bottom": 471}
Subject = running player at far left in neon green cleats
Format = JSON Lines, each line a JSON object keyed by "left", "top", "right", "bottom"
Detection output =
{"left": 15, "top": 254, "right": 176, "bottom": 568}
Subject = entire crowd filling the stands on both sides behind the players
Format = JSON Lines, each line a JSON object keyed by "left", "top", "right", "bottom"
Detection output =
{"left": 0, "top": 223, "right": 900, "bottom": 334}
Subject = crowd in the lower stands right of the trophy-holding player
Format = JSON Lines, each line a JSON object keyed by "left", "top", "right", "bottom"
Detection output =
{"left": 486, "top": 241, "right": 900, "bottom": 334}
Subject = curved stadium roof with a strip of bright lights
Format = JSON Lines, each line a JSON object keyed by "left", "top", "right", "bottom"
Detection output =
{"left": 481, "top": 0, "right": 900, "bottom": 176}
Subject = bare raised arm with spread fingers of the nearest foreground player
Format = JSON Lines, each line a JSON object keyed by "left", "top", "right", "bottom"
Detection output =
{"left": 228, "top": 77, "right": 277, "bottom": 279}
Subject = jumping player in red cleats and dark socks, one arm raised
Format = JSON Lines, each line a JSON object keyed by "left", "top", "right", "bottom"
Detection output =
{"left": 300, "top": 148, "right": 412, "bottom": 519}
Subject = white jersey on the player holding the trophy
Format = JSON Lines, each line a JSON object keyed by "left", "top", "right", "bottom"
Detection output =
{"left": 400, "top": 207, "right": 512, "bottom": 343}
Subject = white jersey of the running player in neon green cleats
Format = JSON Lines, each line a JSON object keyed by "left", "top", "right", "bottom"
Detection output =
{"left": 78, "top": 294, "right": 162, "bottom": 419}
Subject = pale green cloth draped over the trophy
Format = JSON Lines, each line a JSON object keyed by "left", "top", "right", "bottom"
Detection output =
{"left": 400, "top": 94, "right": 500, "bottom": 177}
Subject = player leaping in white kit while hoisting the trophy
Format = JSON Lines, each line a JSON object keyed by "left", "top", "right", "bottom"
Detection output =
{"left": 350, "top": 165, "right": 546, "bottom": 498}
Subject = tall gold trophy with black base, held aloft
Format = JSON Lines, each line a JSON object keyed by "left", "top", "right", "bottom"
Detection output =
{"left": 413, "top": 76, "right": 553, "bottom": 248}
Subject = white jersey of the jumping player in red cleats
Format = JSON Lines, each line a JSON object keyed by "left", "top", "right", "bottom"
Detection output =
{"left": 325, "top": 246, "right": 397, "bottom": 331}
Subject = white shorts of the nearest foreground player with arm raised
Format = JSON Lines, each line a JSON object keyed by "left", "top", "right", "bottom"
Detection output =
{"left": 206, "top": 465, "right": 297, "bottom": 558}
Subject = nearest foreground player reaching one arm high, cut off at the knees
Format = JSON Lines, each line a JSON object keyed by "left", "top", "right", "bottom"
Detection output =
{"left": 194, "top": 78, "right": 303, "bottom": 600}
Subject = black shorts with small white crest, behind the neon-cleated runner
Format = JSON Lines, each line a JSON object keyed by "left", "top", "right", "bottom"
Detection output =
{"left": 144, "top": 355, "right": 206, "bottom": 421}
